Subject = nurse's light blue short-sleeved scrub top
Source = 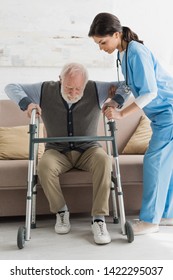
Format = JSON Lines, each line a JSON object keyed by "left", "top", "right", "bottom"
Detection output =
{"left": 122, "top": 41, "right": 173, "bottom": 138}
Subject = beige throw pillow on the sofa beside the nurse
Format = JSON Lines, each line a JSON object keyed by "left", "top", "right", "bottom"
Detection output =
{"left": 122, "top": 116, "right": 152, "bottom": 154}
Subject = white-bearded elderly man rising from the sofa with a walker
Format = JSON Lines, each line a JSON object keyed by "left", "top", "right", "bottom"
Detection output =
{"left": 5, "top": 63, "right": 127, "bottom": 244}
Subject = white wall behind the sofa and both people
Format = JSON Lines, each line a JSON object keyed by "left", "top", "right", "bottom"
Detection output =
{"left": 0, "top": 0, "right": 173, "bottom": 99}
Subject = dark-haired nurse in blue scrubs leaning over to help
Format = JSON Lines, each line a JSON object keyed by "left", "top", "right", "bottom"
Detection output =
{"left": 88, "top": 13, "right": 173, "bottom": 235}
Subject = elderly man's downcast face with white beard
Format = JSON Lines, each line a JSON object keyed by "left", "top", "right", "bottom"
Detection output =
{"left": 61, "top": 73, "right": 84, "bottom": 104}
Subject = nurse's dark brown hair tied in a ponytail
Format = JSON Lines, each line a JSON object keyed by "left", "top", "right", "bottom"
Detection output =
{"left": 88, "top": 13, "right": 143, "bottom": 44}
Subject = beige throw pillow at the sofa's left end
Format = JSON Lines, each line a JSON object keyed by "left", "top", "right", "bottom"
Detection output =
{"left": 0, "top": 123, "right": 44, "bottom": 160}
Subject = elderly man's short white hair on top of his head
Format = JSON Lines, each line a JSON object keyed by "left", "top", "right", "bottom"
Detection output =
{"left": 60, "top": 62, "right": 88, "bottom": 87}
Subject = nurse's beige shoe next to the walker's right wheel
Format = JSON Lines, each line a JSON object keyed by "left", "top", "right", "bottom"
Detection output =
{"left": 132, "top": 221, "right": 159, "bottom": 235}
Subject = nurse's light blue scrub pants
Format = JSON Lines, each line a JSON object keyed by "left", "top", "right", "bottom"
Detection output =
{"left": 139, "top": 123, "right": 173, "bottom": 224}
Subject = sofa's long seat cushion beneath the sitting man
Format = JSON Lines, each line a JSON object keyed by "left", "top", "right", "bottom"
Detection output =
{"left": 0, "top": 155, "right": 143, "bottom": 189}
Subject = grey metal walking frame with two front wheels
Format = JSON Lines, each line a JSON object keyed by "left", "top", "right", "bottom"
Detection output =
{"left": 17, "top": 109, "right": 134, "bottom": 249}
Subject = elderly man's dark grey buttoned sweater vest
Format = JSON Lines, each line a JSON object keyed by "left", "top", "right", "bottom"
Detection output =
{"left": 40, "top": 81, "right": 101, "bottom": 153}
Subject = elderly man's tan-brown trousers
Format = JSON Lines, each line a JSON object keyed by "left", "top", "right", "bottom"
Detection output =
{"left": 38, "top": 147, "right": 112, "bottom": 216}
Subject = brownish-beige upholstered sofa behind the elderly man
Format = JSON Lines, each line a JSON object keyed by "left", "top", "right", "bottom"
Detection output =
{"left": 0, "top": 100, "right": 146, "bottom": 217}
